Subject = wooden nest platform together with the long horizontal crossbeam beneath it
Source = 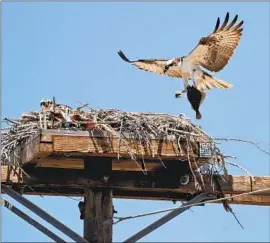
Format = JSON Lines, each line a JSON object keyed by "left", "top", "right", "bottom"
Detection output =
{"left": 1, "top": 130, "right": 270, "bottom": 206}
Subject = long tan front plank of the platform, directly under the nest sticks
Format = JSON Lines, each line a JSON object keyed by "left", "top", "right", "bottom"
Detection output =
{"left": 53, "top": 136, "right": 193, "bottom": 159}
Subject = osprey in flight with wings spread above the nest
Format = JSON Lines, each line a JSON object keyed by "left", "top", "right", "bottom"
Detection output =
{"left": 118, "top": 13, "right": 244, "bottom": 97}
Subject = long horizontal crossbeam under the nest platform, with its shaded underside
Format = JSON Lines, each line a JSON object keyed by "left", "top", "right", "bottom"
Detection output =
{"left": 1, "top": 166, "right": 270, "bottom": 206}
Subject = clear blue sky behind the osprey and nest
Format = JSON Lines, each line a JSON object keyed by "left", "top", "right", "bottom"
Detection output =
{"left": 2, "top": 2, "right": 270, "bottom": 242}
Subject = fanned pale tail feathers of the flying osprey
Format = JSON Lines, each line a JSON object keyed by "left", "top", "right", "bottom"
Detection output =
{"left": 197, "top": 73, "right": 233, "bottom": 90}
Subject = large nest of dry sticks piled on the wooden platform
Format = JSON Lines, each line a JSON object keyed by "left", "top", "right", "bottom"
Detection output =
{"left": 1, "top": 101, "right": 227, "bottom": 183}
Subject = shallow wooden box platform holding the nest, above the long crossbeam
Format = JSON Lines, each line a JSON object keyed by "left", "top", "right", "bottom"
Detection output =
{"left": 17, "top": 130, "right": 210, "bottom": 170}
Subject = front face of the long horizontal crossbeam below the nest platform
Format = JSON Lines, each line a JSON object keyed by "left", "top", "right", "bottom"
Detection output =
{"left": 1, "top": 166, "right": 270, "bottom": 195}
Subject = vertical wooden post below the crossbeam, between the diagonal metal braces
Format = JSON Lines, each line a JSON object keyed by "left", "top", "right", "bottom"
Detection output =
{"left": 84, "top": 188, "right": 113, "bottom": 243}
